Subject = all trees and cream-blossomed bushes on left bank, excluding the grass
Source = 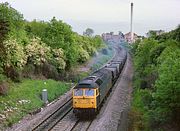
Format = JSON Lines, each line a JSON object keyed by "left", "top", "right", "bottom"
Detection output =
{"left": 0, "top": 2, "right": 104, "bottom": 84}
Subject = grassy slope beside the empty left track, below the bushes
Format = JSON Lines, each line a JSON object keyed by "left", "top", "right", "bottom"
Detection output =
{"left": 0, "top": 79, "right": 70, "bottom": 130}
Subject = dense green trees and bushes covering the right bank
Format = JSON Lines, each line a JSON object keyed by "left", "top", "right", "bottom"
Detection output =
{"left": 133, "top": 26, "right": 180, "bottom": 130}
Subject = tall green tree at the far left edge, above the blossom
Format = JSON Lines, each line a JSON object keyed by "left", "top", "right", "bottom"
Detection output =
{"left": 0, "top": 2, "right": 25, "bottom": 73}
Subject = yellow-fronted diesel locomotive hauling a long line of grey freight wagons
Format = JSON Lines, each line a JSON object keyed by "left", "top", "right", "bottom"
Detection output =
{"left": 72, "top": 48, "right": 127, "bottom": 118}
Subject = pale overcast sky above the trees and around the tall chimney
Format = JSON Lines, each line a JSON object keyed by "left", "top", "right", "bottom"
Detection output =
{"left": 0, "top": 0, "right": 180, "bottom": 35}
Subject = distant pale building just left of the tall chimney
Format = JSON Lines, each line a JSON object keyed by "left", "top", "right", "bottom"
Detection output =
{"left": 102, "top": 31, "right": 124, "bottom": 43}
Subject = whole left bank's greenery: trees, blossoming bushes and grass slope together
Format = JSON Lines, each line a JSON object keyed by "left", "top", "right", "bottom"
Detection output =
{"left": 0, "top": 2, "right": 104, "bottom": 130}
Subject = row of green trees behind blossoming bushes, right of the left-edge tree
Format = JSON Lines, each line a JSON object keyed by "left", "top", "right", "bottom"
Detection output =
{"left": 26, "top": 17, "right": 103, "bottom": 69}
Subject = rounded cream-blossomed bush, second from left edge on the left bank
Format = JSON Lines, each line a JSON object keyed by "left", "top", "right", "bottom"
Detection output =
{"left": 25, "top": 38, "right": 51, "bottom": 65}
